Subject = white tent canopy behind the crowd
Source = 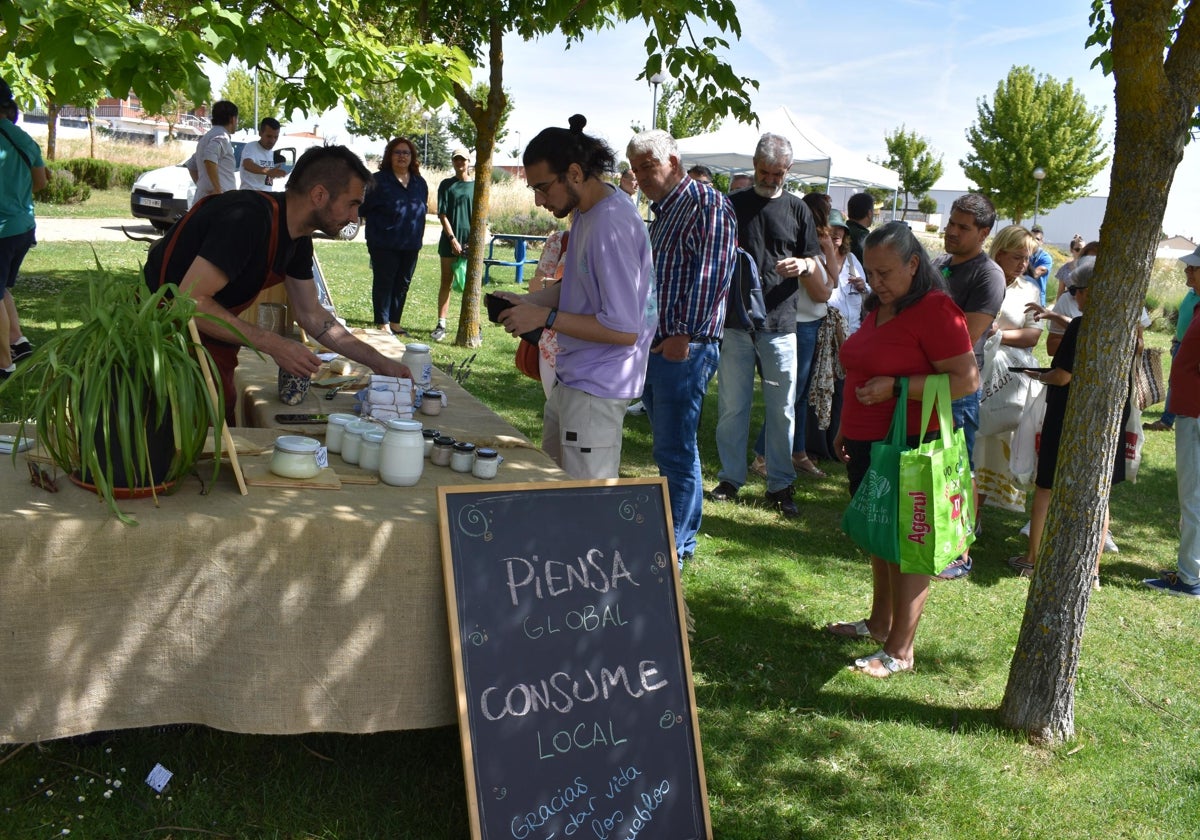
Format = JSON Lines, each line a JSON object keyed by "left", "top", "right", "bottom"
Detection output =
{"left": 678, "top": 106, "right": 900, "bottom": 191}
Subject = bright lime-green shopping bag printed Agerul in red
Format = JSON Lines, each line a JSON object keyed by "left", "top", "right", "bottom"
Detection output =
{"left": 899, "top": 373, "right": 974, "bottom": 575}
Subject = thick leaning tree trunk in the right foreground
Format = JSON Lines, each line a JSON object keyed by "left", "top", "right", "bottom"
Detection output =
{"left": 1000, "top": 0, "right": 1200, "bottom": 743}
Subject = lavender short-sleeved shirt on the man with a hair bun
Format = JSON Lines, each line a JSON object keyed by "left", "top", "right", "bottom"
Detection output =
{"left": 556, "top": 188, "right": 658, "bottom": 400}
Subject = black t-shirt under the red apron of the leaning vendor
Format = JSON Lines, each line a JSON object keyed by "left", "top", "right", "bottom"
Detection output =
{"left": 144, "top": 190, "right": 312, "bottom": 310}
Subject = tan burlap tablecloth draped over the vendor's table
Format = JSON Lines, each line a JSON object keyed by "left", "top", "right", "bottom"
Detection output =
{"left": 0, "top": 333, "right": 566, "bottom": 742}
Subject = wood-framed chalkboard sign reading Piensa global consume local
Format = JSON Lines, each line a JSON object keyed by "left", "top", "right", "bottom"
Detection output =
{"left": 438, "top": 479, "right": 712, "bottom": 840}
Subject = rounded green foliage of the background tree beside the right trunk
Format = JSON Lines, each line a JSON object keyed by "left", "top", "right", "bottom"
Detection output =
{"left": 959, "top": 67, "right": 1109, "bottom": 223}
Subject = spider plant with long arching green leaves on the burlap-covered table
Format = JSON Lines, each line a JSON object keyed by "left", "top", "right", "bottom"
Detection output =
{"left": 5, "top": 270, "right": 224, "bottom": 524}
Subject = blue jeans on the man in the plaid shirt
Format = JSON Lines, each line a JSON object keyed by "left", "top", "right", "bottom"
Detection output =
{"left": 642, "top": 343, "right": 721, "bottom": 562}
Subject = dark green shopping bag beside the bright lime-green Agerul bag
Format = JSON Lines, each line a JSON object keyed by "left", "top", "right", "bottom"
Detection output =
{"left": 841, "top": 378, "right": 908, "bottom": 563}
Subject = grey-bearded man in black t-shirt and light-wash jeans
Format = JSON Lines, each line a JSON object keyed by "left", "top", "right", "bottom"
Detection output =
{"left": 709, "top": 133, "right": 829, "bottom": 517}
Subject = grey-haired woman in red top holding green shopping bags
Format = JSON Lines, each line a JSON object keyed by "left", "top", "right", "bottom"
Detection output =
{"left": 826, "top": 222, "right": 979, "bottom": 678}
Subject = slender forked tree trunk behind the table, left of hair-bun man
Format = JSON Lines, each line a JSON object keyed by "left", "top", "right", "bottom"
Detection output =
{"left": 454, "top": 13, "right": 508, "bottom": 347}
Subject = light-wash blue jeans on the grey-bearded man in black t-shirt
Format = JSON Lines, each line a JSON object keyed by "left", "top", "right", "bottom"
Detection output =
{"left": 716, "top": 329, "right": 796, "bottom": 492}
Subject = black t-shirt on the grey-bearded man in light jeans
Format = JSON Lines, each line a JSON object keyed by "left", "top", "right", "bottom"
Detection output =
{"left": 730, "top": 190, "right": 821, "bottom": 332}
